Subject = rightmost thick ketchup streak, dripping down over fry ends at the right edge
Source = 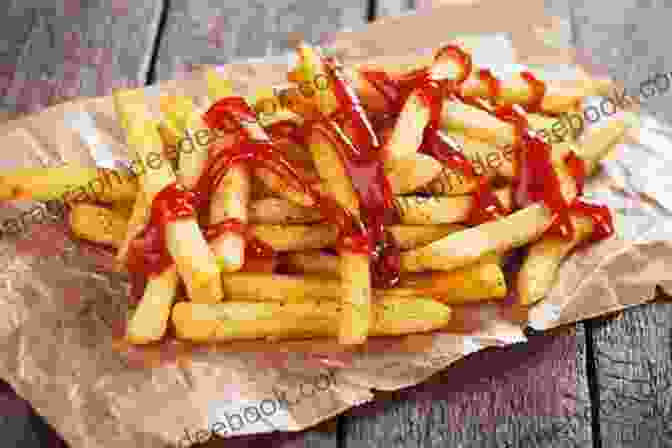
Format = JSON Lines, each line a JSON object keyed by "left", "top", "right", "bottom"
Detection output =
{"left": 496, "top": 106, "right": 614, "bottom": 241}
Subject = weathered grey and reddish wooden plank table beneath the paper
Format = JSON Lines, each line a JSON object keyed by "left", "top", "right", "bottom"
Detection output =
{"left": 0, "top": 0, "right": 672, "bottom": 448}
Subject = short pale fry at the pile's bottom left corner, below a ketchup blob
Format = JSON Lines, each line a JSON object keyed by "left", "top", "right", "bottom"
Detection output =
{"left": 126, "top": 265, "right": 178, "bottom": 344}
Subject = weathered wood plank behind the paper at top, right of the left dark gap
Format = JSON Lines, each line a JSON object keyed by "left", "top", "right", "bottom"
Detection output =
{"left": 156, "top": 0, "right": 367, "bottom": 79}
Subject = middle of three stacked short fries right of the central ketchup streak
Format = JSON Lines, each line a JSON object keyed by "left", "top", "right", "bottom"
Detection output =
{"left": 394, "top": 188, "right": 511, "bottom": 225}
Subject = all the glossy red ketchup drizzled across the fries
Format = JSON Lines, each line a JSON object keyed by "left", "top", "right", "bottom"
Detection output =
{"left": 127, "top": 45, "right": 614, "bottom": 300}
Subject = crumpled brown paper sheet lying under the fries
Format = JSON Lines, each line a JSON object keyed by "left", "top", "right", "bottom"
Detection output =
{"left": 0, "top": 2, "right": 672, "bottom": 448}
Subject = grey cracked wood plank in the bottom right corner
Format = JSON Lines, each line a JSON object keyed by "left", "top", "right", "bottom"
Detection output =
{"left": 591, "top": 302, "right": 672, "bottom": 448}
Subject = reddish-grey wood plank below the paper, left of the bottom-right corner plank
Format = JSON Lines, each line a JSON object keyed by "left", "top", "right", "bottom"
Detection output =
{"left": 342, "top": 326, "right": 592, "bottom": 448}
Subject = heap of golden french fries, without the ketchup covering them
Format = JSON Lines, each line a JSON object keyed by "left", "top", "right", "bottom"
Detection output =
{"left": 0, "top": 44, "right": 625, "bottom": 345}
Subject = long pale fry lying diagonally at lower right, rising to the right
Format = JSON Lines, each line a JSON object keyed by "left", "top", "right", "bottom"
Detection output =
{"left": 401, "top": 203, "right": 552, "bottom": 272}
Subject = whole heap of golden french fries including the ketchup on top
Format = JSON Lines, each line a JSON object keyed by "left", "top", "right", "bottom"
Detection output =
{"left": 5, "top": 40, "right": 626, "bottom": 345}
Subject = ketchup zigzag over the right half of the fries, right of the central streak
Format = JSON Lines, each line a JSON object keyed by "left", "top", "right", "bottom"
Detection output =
{"left": 361, "top": 45, "right": 614, "bottom": 241}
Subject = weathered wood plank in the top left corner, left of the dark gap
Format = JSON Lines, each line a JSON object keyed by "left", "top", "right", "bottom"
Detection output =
{"left": 0, "top": 0, "right": 162, "bottom": 112}
